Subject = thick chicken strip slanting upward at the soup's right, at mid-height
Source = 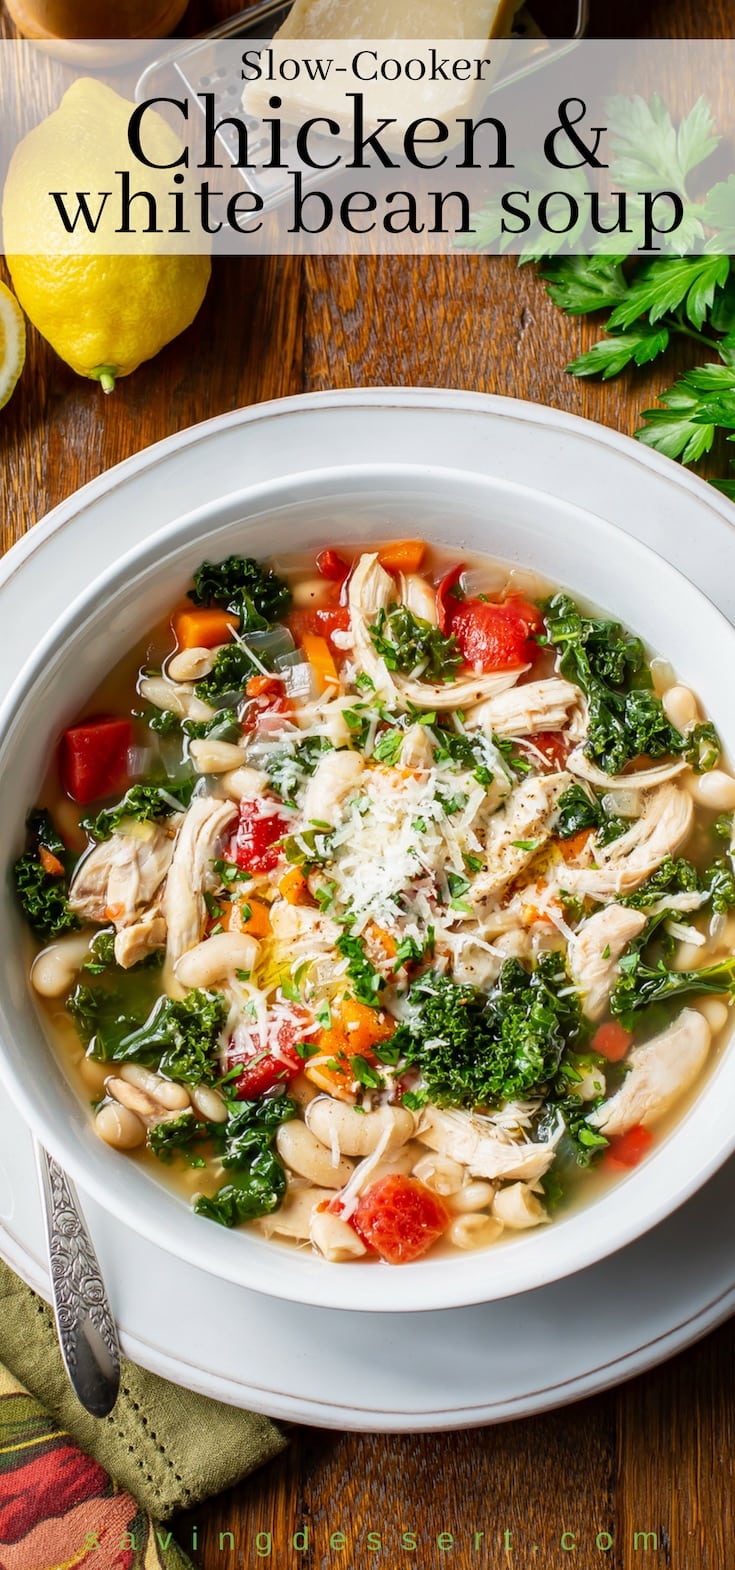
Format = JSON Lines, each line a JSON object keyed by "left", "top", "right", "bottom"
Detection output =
{"left": 562, "top": 783, "right": 694, "bottom": 900}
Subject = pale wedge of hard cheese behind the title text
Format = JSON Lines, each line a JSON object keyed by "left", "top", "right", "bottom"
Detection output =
{"left": 242, "top": 0, "right": 518, "bottom": 144}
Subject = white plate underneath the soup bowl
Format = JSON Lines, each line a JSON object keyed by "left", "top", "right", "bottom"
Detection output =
{"left": 0, "top": 389, "right": 735, "bottom": 1430}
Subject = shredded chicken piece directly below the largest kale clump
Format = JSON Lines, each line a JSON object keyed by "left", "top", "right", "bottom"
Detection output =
{"left": 418, "top": 1107, "right": 556, "bottom": 1182}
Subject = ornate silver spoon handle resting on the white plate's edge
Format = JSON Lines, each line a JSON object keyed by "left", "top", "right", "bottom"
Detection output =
{"left": 36, "top": 1145, "right": 119, "bottom": 1418}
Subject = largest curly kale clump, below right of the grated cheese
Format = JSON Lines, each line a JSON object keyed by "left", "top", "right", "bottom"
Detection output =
{"left": 391, "top": 955, "right": 583, "bottom": 1110}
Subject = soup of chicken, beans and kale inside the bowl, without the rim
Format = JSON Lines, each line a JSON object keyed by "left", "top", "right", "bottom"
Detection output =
{"left": 16, "top": 540, "right": 735, "bottom": 1265}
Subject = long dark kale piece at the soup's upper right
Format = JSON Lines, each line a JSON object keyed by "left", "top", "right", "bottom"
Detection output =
{"left": 545, "top": 593, "right": 719, "bottom": 774}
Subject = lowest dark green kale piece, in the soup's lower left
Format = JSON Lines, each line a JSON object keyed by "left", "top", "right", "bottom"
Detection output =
{"left": 195, "top": 1090, "right": 297, "bottom": 1226}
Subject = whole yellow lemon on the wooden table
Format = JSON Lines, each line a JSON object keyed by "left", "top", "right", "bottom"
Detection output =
{"left": 3, "top": 77, "right": 210, "bottom": 393}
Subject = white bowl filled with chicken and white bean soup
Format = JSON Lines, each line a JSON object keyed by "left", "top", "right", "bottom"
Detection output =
{"left": 0, "top": 466, "right": 735, "bottom": 1311}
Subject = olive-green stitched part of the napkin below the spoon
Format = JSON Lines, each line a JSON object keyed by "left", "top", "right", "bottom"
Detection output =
{"left": 0, "top": 1261, "right": 286, "bottom": 1521}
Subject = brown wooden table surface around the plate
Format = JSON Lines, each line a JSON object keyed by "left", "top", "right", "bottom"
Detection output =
{"left": 0, "top": 0, "right": 735, "bottom": 1570}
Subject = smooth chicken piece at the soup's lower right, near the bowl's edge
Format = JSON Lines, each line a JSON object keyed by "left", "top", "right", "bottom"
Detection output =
{"left": 589, "top": 1008, "right": 711, "bottom": 1135}
